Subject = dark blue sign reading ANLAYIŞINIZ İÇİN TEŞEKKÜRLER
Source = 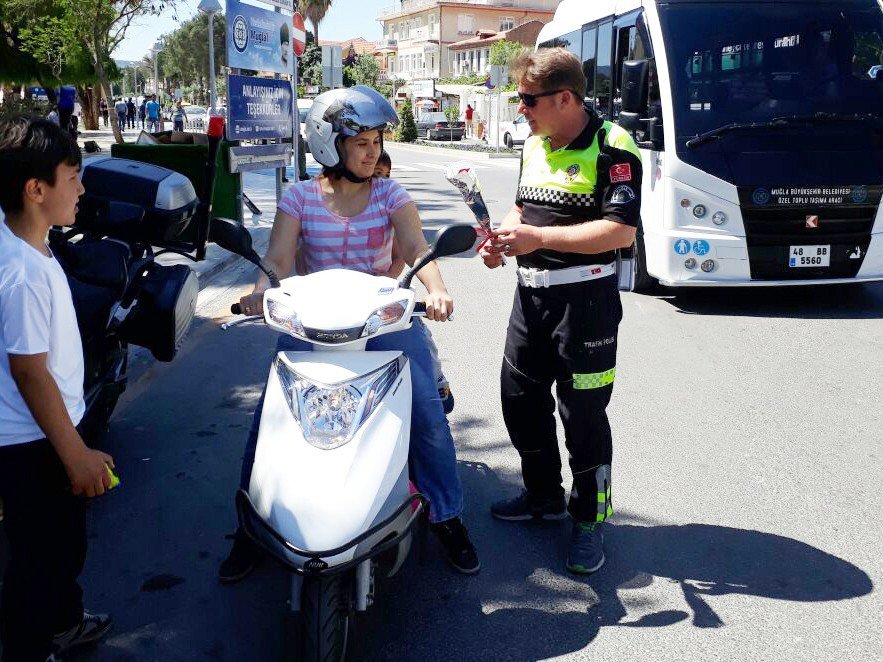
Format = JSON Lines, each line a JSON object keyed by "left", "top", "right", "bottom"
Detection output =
{"left": 227, "top": 74, "right": 291, "bottom": 140}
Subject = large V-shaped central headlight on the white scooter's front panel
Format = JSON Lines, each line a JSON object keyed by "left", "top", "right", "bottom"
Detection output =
{"left": 276, "top": 357, "right": 405, "bottom": 450}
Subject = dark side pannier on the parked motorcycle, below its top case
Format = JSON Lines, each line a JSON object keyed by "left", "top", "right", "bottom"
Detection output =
{"left": 120, "top": 262, "right": 199, "bottom": 361}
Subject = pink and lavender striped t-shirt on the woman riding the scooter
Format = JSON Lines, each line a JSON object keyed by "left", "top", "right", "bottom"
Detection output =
{"left": 279, "top": 178, "right": 411, "bottom": 274}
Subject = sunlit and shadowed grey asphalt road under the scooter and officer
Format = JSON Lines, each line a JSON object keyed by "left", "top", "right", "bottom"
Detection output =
{"left": 8, "top": 147, "right": 883, "bottom": 661}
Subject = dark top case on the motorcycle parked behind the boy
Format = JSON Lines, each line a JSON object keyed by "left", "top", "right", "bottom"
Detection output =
{"left": 77, "top": 155, "right": 199, "bottom": 244}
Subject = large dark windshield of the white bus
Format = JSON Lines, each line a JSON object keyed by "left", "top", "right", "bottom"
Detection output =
{"left": 660, "top": 0, "right": 883, "bottom": 143}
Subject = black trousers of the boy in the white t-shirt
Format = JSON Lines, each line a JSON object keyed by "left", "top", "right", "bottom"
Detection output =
{"left": 0, "top": 439, "right": 86, "bottom": 662}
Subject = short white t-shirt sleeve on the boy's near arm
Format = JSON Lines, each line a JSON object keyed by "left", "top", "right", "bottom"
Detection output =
{"left": 0, "top": 282, "right": 52, "bottom": 354}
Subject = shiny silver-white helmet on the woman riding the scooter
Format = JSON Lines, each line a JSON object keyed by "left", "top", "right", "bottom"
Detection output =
{"left": 304, "top": 85, "right": 399, "bottom": 168}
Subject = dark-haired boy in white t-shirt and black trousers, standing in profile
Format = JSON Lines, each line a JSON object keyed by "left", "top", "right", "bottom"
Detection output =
{"left": 0, "top": 118, "right": 113, "bottom": 662}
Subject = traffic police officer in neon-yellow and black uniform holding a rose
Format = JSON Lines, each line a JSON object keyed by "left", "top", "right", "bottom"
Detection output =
{"left": 481, "top": 48, "right": 642, "bottom": 574}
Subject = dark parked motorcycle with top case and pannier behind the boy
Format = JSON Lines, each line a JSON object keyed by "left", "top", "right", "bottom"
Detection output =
{"left": 49, "top": 119, "right": 223, "bottom": 441}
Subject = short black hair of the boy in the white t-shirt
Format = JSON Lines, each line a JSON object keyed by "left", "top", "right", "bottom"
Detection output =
{"left": 0, "top": 116, "right": 83, "bottom": 214}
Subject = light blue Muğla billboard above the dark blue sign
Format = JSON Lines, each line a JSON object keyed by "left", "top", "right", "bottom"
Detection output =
{"left": 227, "top": 0, "right": 294, "bottom": 75}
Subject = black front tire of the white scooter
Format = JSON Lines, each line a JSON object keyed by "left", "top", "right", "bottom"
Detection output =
{"left": 300, "top": 573, "right": 353, "bottom": 662}
